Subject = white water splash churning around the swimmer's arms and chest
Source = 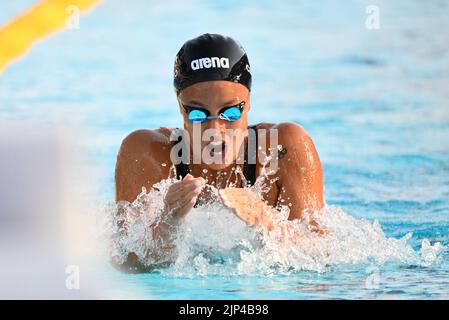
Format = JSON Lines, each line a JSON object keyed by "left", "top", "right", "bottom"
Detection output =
{"left": 102, "top": 179, "right": 443, "bottom": 277}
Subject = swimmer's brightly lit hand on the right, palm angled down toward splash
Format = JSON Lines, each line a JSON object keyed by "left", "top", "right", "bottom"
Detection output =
{"left": 218, "top": 188, "right": 274, "bottom": 230}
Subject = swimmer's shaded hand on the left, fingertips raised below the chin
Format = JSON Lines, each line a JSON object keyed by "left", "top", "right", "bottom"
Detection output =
{"left": 165, "top": 174, "right": 205, "bottom": 223}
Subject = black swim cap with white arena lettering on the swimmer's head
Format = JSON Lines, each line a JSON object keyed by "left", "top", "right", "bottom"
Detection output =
{"left": 173, "top": 33, "right": 251, "bottom": 94}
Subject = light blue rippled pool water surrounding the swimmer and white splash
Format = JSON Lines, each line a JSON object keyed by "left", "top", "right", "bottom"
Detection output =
{"left": 0, "top": 0, "right": 449, "bottom": 299}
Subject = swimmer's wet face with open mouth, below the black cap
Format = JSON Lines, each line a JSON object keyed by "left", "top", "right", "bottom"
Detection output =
{"left": 178, "top": 81, "right": 250, "bottom": 170}
